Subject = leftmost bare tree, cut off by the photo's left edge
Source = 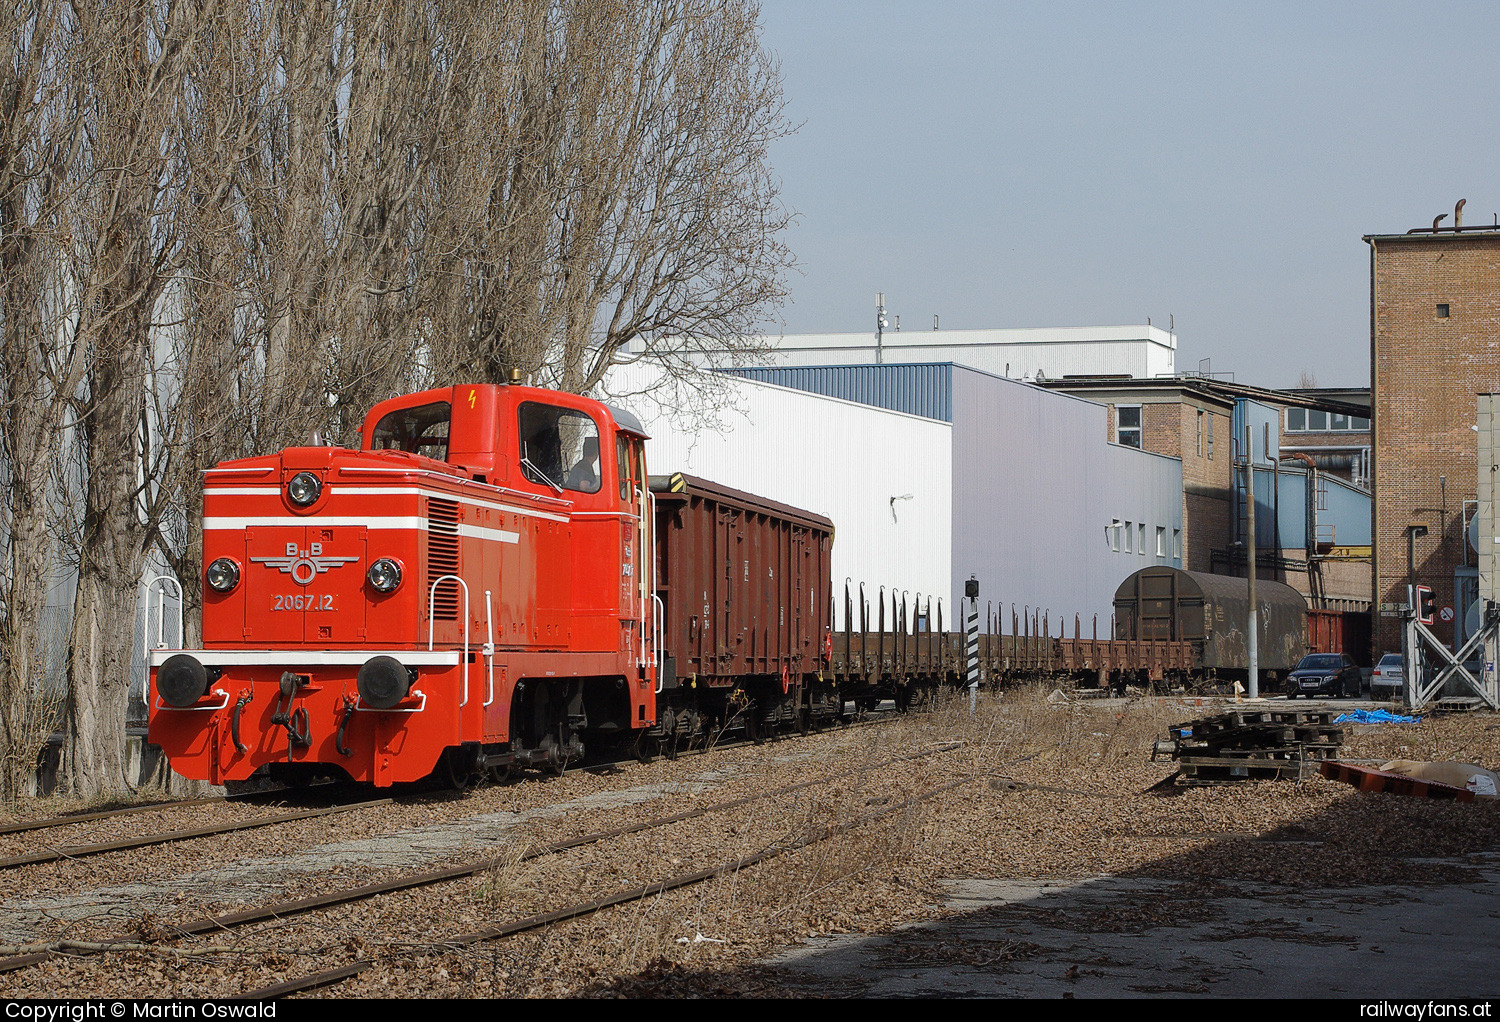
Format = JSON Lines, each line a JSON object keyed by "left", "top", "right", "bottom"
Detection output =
{"left": 0, "top": 3, "right": 86, "bottom": 798}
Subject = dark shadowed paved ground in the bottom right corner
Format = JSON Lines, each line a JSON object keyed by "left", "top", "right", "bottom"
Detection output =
{"left": 776, "top": 854, "right": 1500, "bottom": 1001}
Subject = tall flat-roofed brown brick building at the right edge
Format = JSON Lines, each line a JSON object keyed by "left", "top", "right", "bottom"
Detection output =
{"left": 1365, "top": 218, "right": 1500, "bottom": 651}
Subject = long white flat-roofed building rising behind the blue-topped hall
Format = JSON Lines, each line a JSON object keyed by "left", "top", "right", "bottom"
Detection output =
{"left": 639, "top": 324, "right": 1178, "bottom": 380}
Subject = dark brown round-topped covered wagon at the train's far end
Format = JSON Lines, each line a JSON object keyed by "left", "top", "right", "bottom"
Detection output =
{"left": 1115, "top": 567, "right": 1308, "bottom": 674}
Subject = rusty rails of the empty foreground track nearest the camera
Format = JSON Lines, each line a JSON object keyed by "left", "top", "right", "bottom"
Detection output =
{"left": 0, "top": 732, "right": 962, "bottom": 989}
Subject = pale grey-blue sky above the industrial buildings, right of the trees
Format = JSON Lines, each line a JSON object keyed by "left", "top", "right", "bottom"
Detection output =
{"left": 762, "top": 0, "right": 1500, "bottom": 387}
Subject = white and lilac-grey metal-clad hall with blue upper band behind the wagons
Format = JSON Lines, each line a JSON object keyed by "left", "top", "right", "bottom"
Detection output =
{"left": 609, "top": 363, "right": 1182, "bottom": 636}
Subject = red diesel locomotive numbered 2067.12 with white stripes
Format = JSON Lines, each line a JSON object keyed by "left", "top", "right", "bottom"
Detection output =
{"left": 152, "top": 384, "right": 656, "bottom": 785}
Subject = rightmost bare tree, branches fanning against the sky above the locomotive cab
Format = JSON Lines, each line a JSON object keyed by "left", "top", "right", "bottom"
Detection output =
{"left": 546, "top": 0, "right": 792, "bottom": 390}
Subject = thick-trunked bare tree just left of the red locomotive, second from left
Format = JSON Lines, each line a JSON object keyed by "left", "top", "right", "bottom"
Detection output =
{"left": 55, "top": 0, "right": 212, "bottom": 795}
